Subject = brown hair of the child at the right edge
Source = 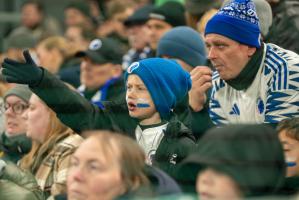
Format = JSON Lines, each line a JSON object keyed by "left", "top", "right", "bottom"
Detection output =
{"left": 276, "top": 118, "right": 299, "bottom": 141}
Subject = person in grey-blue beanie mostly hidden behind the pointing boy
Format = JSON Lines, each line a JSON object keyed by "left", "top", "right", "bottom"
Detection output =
{"left": 157, "top": 26, "right": 213, "bottom": 139}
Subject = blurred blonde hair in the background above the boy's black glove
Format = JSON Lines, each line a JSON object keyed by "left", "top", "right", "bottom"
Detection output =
{"left": 38, "top": 36, "right": 74, "bottom": 59}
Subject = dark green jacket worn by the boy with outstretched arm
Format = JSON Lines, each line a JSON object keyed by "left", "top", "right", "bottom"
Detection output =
{"left": 31, "top": 70, "right": 195, "bottom": 176}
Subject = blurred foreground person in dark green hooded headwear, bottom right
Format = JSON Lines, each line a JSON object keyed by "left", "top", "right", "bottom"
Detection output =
{"left": 179, "top": 125, "right": 286, "bottom": 199}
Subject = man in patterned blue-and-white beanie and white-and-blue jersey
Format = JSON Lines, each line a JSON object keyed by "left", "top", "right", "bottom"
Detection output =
{"left": 192, "top": 0, "right": 299, "bottom": 125}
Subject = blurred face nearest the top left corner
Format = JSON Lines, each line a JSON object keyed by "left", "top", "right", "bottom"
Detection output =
{"left": 21, "top": 4, "right": 42, "bottom": 28}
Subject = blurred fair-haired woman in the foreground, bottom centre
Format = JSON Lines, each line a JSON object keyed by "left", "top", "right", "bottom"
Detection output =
{"left": 57, "top": 131, "right": 180, "bottom": 199}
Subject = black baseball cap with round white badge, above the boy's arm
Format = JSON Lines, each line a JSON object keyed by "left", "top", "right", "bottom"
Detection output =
{"left": 75, "top": 38, "right": 123, "bottom": 64}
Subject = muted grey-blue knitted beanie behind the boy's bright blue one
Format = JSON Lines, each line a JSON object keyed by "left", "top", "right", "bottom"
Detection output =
{"left": 157, "top": 26, "right": 207, "bottom": 67}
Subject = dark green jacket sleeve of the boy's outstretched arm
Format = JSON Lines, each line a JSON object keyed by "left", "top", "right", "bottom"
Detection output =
{"left": 31, "top": 69, "right": 116, "bottom": 133}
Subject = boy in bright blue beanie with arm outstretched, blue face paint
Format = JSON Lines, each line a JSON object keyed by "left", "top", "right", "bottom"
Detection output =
{"left": 2, "top": 51, "right": 194, "bottom": 176}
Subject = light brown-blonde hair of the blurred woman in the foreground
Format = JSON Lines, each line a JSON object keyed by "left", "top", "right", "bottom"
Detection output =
{"left": 87, "top": 131, "right": 149, "bottom": 192}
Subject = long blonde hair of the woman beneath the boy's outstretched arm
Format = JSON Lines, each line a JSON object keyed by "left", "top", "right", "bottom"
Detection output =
{"left": 20, "top": 95, "right": 74, "bottom": 174}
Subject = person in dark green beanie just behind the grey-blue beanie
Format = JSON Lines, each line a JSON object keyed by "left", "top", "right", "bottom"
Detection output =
{"left": 146, "top": 1, "right": 186, "bottom": 53}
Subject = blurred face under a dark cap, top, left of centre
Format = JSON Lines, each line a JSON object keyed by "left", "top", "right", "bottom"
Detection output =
{"left": 64, "top": 8, "right": 87, "bottom": 26}
